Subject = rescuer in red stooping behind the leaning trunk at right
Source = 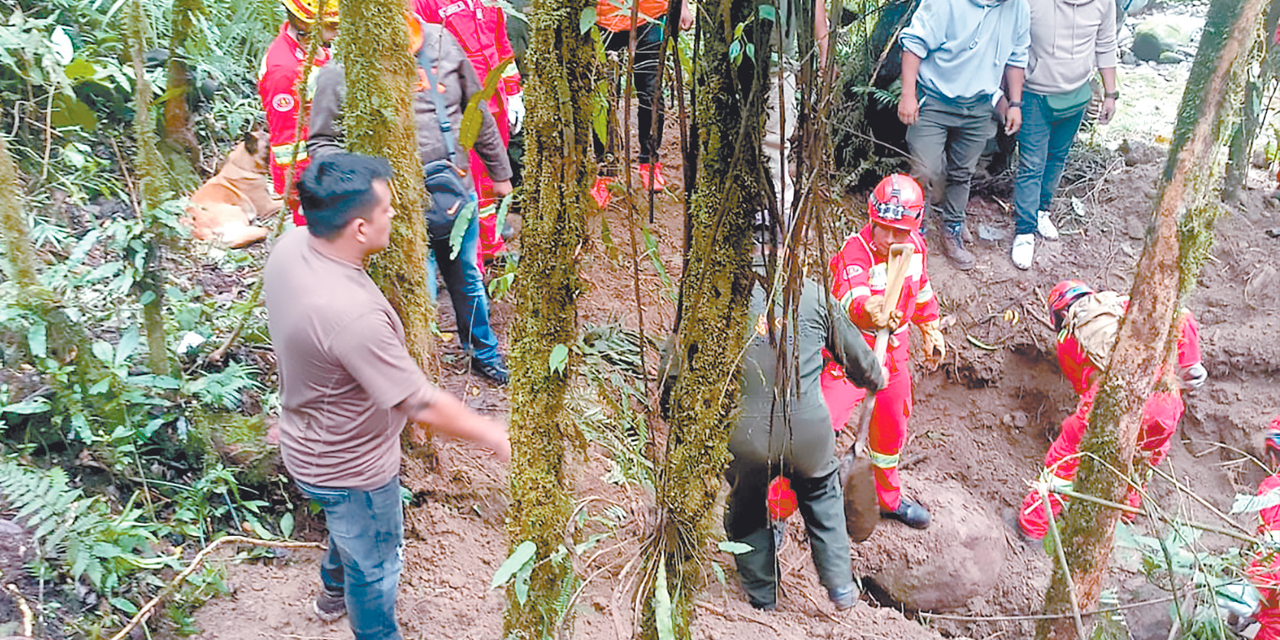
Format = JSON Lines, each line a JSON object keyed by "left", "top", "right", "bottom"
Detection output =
{"left": 1018, "top": 280, "right": 1208, "bottom": 540}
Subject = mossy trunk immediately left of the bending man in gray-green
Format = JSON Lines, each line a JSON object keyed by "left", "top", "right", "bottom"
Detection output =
{"left": 637, "top": 0, "right": 772, "bottom": 639}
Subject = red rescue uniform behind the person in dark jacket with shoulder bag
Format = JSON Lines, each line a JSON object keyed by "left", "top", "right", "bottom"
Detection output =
{"left": 413, "top": 0, "right": 520, "bottom": 262}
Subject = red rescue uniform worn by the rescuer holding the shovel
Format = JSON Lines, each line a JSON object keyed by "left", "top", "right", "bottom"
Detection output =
{"left": 822, "top": 223, "right": 938, "bottom": 511}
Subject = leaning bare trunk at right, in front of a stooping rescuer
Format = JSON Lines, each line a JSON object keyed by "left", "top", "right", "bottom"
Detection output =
{"left": 1037, "top": 0, "right": 1266, "bottom": 639}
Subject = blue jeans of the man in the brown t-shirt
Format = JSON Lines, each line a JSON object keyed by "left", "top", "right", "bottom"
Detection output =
{"left": 298, "top": 477, "right": 404, "bottom": 640}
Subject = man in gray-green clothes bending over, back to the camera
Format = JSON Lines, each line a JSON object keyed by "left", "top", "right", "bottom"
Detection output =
{"left": 663, "top": 211, "right": 884, "bottom": 611}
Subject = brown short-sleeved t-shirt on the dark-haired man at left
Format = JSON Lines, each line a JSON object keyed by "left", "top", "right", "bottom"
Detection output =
{"left": 264, "top": 227, "right": 435, "bottom": 490}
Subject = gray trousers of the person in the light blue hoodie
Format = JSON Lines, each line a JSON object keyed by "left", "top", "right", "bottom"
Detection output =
{"left": 906, "top": 87, "right": 996, "bottom": 230}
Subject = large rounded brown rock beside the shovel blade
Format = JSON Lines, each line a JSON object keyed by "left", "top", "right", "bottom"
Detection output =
{"left": 854, "top": 483, "right": 1007, "bottom": 611}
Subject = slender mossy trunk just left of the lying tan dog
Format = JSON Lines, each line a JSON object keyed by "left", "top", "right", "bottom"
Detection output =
{"left": 125, "top": 0, "right": 170, "bottom": 375}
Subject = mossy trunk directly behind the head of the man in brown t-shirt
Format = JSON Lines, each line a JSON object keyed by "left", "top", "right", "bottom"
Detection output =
{"left": 337, "top": 0, "right": 439, "bottom": 376}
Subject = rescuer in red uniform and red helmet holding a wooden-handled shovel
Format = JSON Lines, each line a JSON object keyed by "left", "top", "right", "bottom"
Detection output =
{"left": 822, "top": 174, "right": 947, "bottom": 529}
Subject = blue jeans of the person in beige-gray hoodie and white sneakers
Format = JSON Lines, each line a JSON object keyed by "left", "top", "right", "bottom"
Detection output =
{"left": 1014, "top": 91, "right": 1088, "bottom": 234}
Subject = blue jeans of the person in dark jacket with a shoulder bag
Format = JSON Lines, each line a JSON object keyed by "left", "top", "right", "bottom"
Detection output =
{"left": 426, "top": 216, "right": 502, "bottom": 365}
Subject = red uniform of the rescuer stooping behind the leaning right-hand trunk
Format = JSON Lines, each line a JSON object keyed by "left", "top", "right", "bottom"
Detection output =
{"left": 1018, "top": 301, "right": 1201, "bottom": 539}
